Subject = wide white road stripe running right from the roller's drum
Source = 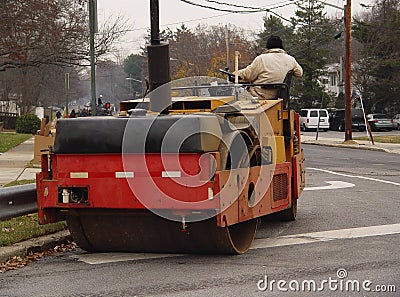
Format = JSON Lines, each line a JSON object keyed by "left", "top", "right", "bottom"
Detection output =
{"left": 250, "top": 224, "right": 400, "bottom": 249}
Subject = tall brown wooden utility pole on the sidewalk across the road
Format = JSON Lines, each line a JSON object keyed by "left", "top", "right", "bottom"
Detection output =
{"left": 344, "top": 0, "right": 353, "bottom": 141}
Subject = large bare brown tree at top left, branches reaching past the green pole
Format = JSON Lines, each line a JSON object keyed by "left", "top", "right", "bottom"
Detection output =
{"left": 0, "top": 0, "right": 127, "bottom": 113}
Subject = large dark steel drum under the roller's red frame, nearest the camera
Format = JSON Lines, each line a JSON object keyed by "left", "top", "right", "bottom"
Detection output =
{"left": 66, "top": 210, "right": 258, "bottom": 254}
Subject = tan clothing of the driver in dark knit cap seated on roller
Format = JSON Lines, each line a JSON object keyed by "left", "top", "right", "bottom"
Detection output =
{"left": 235, "top": 48, "right": 303, "bottom": 99}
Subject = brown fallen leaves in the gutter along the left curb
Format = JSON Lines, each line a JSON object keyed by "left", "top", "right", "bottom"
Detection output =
{"left": 0, "top": 242, "right": 76, "bottom": 273}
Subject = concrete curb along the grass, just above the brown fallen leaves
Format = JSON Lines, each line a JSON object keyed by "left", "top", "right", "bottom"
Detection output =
{"left": 0, "top": 230, "right": 72, "bottom": 263}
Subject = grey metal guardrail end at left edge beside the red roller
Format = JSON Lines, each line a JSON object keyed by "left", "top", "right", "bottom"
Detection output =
{"left": 0, "top": 184, "right": 37, "bottom": 221}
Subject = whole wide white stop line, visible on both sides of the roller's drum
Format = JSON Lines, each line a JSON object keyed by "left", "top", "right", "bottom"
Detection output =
{"left": 74, "top": 224, "right": 400, "bottom": 265}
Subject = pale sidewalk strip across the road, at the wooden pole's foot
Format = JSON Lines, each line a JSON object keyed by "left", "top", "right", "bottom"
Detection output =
{"left": 301, "top": 135, "right": 400, "bottom": 154}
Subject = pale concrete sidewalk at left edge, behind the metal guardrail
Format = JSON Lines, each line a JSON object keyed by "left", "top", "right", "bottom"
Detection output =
{"left": 0, "top": 137, "right": 40, "bottom": 187}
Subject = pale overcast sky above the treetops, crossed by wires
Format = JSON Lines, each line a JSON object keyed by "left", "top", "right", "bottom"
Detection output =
{"left": 97, "top": 0, "right": 374, "bottom": 55}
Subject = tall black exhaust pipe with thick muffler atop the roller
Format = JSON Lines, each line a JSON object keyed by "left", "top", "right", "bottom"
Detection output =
{"left": 147, "top": 0, "right": 171, "bottom": 114}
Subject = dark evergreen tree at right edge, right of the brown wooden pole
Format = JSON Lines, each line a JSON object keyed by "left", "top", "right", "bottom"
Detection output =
{"left": 353, "top": 0, "right": 400, "bottom": 113}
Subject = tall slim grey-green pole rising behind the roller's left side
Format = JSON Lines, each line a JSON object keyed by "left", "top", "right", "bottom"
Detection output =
{"left": 89, "top": 0, "right": 97, "bottom": 115}
